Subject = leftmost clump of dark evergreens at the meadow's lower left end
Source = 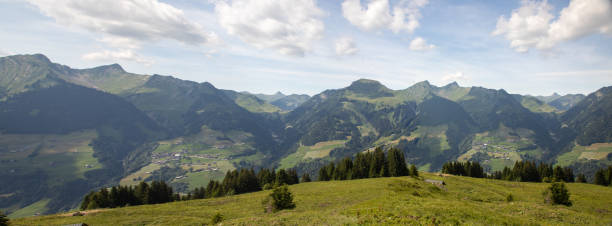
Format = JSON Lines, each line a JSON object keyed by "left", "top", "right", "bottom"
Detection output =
{"left": 81, "top": 181, "right": 175, "bottom": 210}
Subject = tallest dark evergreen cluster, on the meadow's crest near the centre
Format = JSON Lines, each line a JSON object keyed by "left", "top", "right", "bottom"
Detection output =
{"left": 319, "top": 147, "right": 418, "bottom": 181}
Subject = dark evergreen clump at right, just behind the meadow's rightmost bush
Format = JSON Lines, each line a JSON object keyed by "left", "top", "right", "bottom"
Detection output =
{"left": 490, "top": 161, "right": 575, "bottom": 182}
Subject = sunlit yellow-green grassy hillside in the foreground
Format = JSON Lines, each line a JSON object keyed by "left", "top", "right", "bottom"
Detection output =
{"left": 11, "top": 174, "right": 612, "bottom": 225}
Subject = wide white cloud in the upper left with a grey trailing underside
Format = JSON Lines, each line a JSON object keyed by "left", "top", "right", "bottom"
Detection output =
{"left": 28, "top": 0, "right": 218, "bottom": 62}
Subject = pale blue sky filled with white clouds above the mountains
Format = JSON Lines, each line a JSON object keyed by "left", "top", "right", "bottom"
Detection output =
{"left": 0, "top": 0, "right": 612, "bottom": 95}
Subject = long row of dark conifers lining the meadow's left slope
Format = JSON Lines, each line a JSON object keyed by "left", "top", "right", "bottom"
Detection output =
{"left": 80, "top": 168, "right": 310, "bottom": 210}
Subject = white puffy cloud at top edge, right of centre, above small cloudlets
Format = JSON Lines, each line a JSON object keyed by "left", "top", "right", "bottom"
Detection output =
{"left": 342, "top": 0, "right": 429, "bottom": 33}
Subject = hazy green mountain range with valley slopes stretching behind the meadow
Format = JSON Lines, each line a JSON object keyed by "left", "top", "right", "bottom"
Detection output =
{"left": 0, "top": 54, "right": 612, "bottom": 217}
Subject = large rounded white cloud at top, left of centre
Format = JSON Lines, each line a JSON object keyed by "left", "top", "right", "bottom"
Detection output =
{"left": 215, "top": 0, "right": 325, "bottom": 56}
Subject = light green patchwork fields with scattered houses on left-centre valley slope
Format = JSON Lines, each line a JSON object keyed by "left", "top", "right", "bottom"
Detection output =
{"left": 120, "top": 127, "right": 255, "bottom": 190}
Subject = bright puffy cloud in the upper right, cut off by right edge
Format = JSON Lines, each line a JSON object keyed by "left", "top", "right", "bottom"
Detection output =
{"left": 492, "top": 0, "right": 612, "bottom": 52}
